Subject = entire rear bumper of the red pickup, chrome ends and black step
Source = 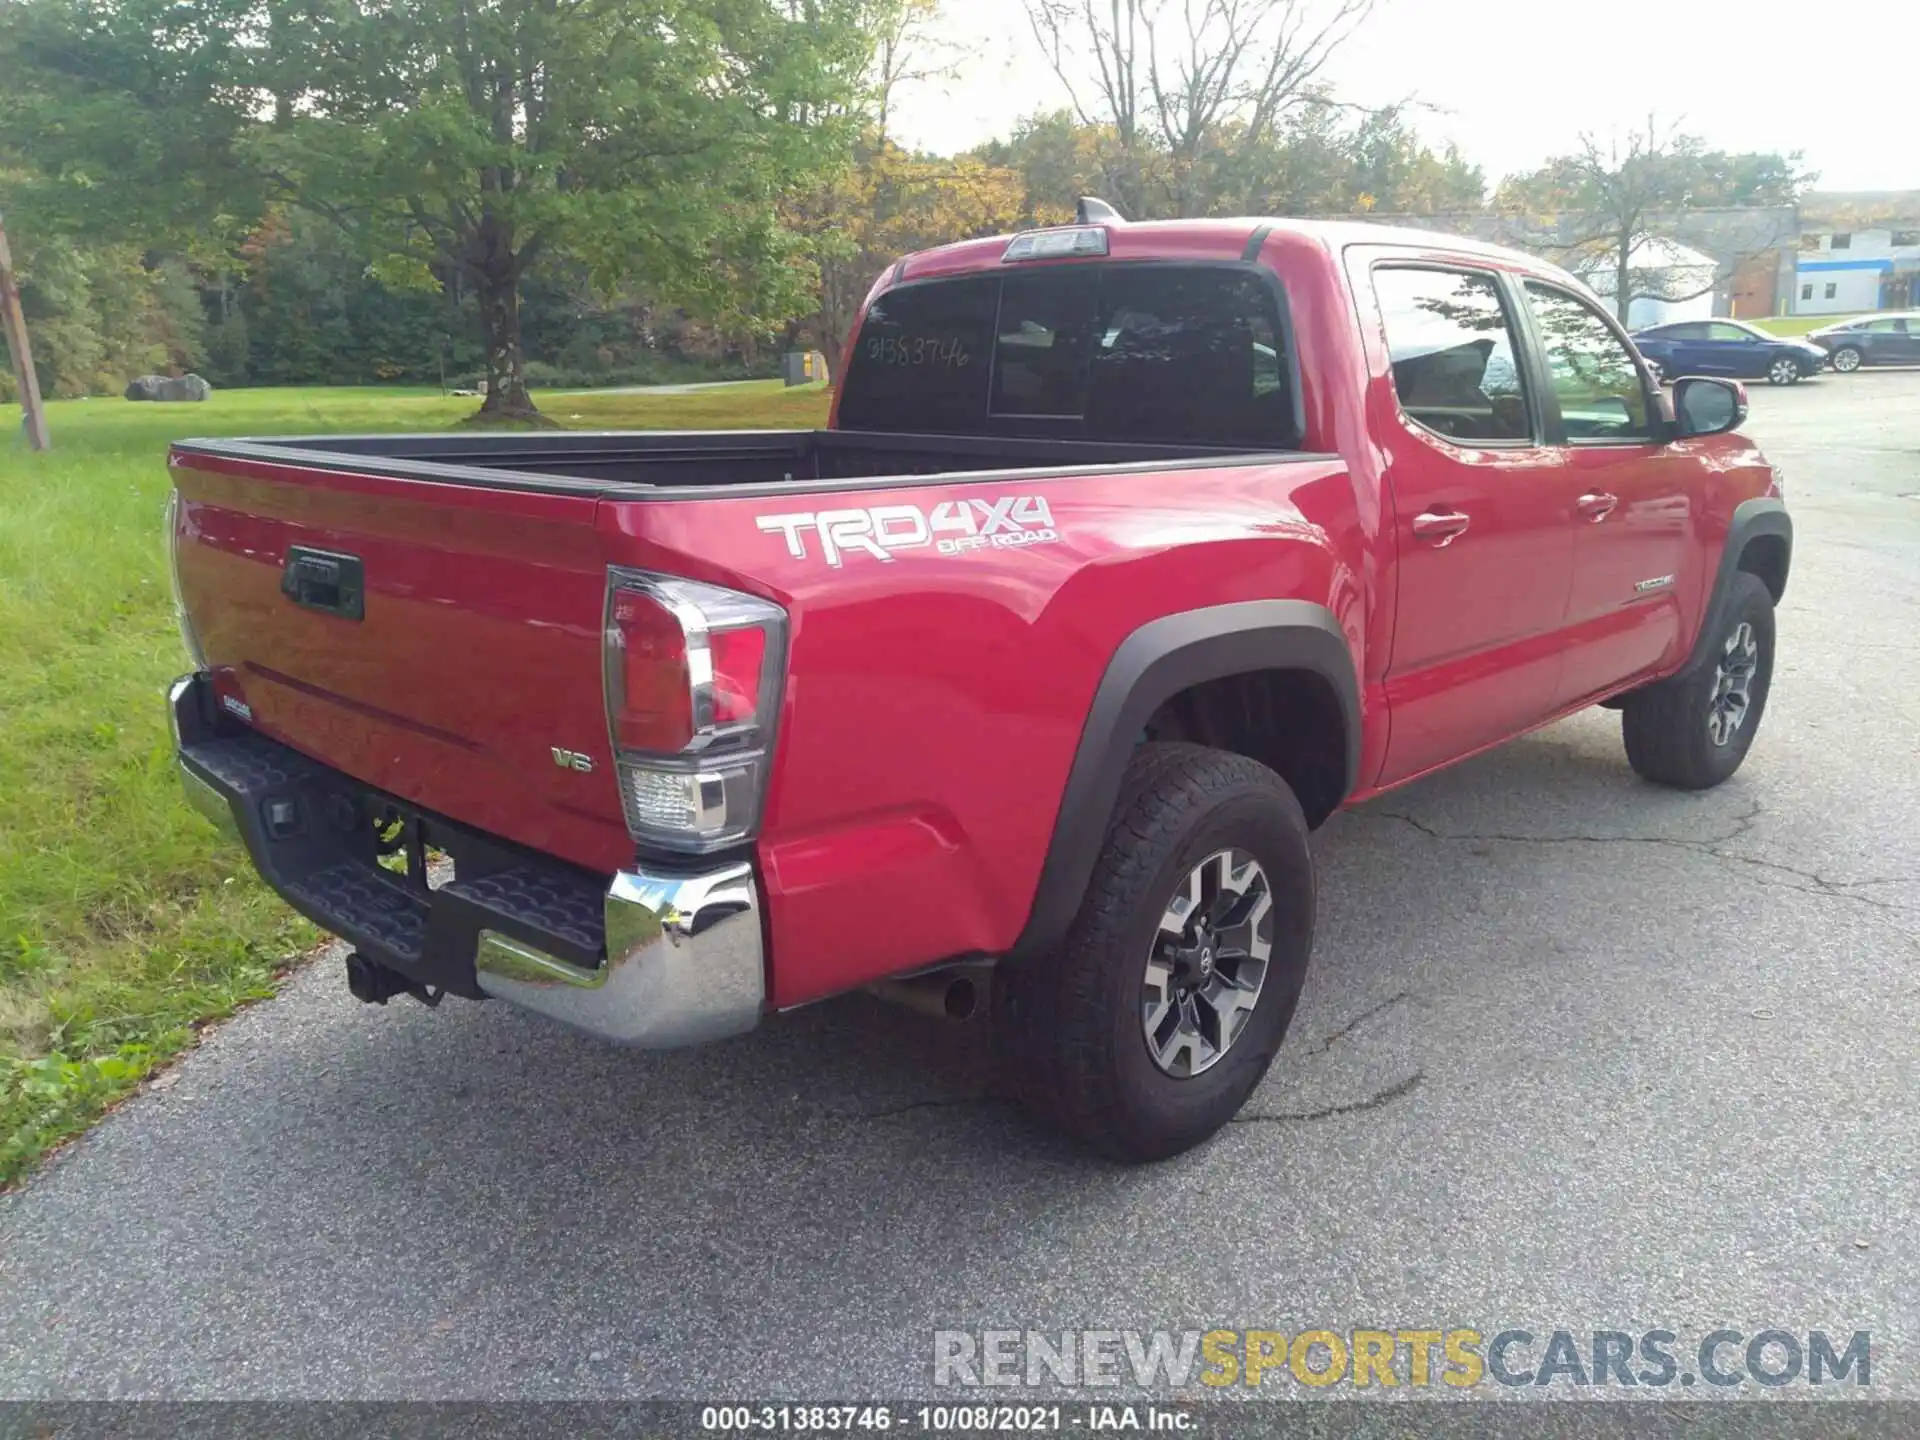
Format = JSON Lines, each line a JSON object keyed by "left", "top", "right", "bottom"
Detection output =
{"left": 167, "top": 676, "right": 766, "bottom": 1048}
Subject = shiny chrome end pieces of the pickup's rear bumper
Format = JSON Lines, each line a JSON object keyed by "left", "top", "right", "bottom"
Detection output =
{"left": 167, "top": 676, "right": 766, "bottom": 1050}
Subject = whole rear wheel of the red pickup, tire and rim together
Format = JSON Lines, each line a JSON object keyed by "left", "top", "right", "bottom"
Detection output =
{"left": 998, "top": 745, "right": 1313, "bottom": 1162}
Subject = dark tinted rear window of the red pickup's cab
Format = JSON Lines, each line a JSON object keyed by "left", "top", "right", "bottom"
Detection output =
{"left": 839, "top": 265, "right": 1296, "bottom": 447}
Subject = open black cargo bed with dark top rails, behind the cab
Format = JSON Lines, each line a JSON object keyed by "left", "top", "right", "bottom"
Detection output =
{"left": 175, "top": 430, "right": 1258, "bottom": 499}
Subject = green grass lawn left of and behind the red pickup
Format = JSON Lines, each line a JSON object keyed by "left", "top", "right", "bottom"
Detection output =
{"left": 0, "top": 382, "right": 826, "bottom": 1187}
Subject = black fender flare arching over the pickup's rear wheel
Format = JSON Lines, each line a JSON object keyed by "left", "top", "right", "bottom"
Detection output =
{"left": 1014, "top": 599, "right": 1361, "bottom": 956}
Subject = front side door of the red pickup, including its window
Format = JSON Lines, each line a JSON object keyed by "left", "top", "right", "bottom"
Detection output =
{"left": 1523, "top": 280, "right": 1697, "bottom": 708}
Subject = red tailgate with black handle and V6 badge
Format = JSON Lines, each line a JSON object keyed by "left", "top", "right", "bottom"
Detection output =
{"left": 173, "top": 451, "right": 632, "bottom": 870}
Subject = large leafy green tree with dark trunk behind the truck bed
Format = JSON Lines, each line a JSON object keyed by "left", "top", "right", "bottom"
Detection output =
{"left": 0, "top": 0, "right": 895, "bottom": 417}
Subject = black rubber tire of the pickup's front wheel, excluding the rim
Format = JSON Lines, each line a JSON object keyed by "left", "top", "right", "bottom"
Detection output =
{"left": 1620, "top": 570, "right": 1774, "bottom": 789}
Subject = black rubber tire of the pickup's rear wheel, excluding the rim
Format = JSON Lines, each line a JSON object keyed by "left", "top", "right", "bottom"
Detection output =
{"left": 995, "top": 745, "right": 1313, "bottom": 1164}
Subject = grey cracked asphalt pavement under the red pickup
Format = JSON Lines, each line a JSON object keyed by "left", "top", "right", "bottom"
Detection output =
{"left": 0, "top": 371, "right": 1920, "bottom": 1398}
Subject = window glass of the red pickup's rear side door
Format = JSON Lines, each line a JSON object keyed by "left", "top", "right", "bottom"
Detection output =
{"left": 1373, "top": 265, "right": 1532, "bottom": 445}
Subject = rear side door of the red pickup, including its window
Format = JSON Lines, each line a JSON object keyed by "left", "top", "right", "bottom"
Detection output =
{"left": 1356, "top": 261, "right": 1578, "bottom": 783}
